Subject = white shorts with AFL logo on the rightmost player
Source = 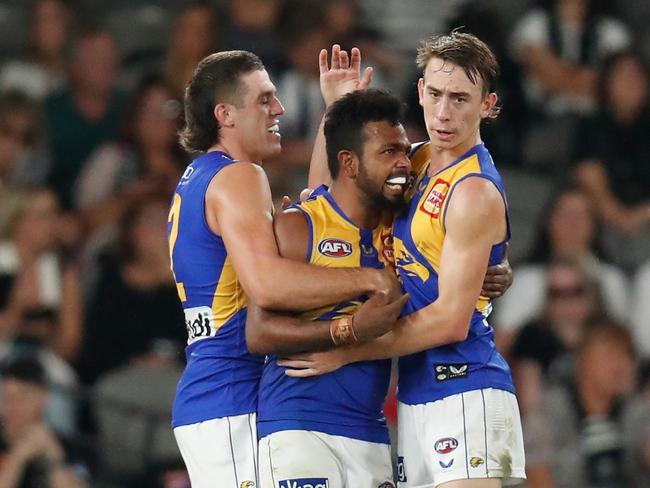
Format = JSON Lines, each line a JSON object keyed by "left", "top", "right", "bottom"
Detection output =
{"left": 397, "top": 388, "right": 526, "bottom": 488}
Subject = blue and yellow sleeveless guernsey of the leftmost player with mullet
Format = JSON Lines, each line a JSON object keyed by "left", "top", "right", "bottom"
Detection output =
{"left": 167, "top": 152, "right": 264, "bottom": 427}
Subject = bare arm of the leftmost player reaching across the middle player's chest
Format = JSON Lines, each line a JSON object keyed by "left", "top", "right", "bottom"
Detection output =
{"left": 205, "top": 162, "right": 399, "bottom": 310}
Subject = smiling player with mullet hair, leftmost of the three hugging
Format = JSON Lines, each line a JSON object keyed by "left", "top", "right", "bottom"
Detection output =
{"left": 168, "top": 51, "right": 402, "bottom": 488}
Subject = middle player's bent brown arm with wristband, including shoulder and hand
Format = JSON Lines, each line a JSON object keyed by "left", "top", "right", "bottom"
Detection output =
{"left": 246, "top": 209, "right": 406, "bottom": 354}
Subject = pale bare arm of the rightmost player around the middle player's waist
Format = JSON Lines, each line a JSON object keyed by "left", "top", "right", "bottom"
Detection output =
{"left": 281, "top": 178, "right": 506, "bottom": 376}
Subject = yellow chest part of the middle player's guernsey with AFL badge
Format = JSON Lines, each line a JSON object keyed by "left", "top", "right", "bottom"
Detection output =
{"left": 293, "top": 186, "right": 393, "bottom": 320}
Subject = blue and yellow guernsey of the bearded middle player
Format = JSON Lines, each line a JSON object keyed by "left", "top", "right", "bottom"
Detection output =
{"left": 257, "top": 186, "right": 392, "bottom": 443}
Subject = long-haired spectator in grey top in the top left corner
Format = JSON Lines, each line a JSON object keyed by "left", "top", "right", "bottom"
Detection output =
{"left": 0, "top": 0, "right": 74, "bottom": 100}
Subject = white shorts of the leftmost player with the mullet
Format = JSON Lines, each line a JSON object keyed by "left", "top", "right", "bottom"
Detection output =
{"left": 174, "top": 413, "right": 258, "bottom": 488}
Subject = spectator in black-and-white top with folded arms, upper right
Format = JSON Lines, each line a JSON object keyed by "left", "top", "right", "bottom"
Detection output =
{"left": 510, "top": 0, "right": 631, "bottom": 171}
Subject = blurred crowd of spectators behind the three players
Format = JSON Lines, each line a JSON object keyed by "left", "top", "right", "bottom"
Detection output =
{"left": 0, "top": 0, "right": 650, "bottom": 488}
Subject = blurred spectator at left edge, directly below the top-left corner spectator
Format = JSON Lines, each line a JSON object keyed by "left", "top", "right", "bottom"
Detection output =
{"left": 0, "top": 91, "right": 50, "bottom": 191}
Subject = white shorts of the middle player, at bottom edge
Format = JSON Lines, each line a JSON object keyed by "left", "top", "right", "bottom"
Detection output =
{"left": 259, "top": 430, "right": 395, "bottom": 488}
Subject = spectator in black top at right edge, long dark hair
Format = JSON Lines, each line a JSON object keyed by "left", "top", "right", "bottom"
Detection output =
{"left": 574, "top": 52, "right": 650, "bottom": 267}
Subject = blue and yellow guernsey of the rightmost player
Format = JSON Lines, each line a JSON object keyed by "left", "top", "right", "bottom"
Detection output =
{"left": 393, "top": 144, "right": 514, "bottom": 405}
